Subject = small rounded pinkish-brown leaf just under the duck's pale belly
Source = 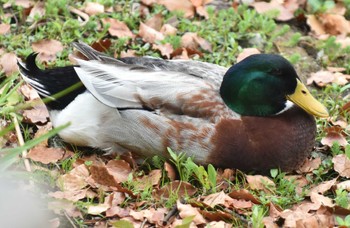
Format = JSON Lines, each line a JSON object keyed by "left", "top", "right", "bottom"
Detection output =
{"left": 106, "top": 160, "right": 132, "bottom": 183}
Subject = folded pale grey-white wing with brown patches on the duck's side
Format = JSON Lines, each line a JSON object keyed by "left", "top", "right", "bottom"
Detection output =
{"left": 75, "top": 60, "right": 232, "bottom": 120}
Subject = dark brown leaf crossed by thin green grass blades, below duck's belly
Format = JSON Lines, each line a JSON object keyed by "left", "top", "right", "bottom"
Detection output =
{"left": 153, "top": 181, "right": 197, "bottom": 199}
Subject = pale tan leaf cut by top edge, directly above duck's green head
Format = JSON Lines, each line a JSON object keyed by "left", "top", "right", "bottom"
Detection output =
{"left": 250, "top": 0, "right": 294, "bottom": 21}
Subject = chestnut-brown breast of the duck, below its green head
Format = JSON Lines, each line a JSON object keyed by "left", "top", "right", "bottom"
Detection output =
{"left": 207, "top": 106, "right": 316, "bottom": 173}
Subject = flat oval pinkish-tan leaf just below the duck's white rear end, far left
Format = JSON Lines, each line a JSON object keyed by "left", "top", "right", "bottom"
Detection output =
{"left": 27, "top": 146, "right": 64, "bottom": 164}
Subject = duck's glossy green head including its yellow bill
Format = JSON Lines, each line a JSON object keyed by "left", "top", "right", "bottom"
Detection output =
{"left": 220, "top": 54, "right": 328, "bottom": 117}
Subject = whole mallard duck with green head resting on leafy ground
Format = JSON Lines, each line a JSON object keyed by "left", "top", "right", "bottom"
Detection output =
{"left": 19, "top": 43, "right": 328, "bottom": 173}
